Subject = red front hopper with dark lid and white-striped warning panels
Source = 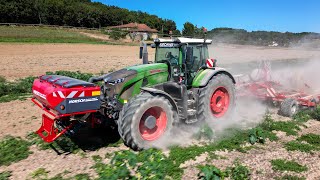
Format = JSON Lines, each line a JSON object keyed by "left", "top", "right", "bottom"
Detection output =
{"left": 32, "top": 75, "right": 101, "bottom": 114}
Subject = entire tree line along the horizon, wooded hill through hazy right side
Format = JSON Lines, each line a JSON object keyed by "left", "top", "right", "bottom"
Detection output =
{"left": 0, "top": 0, "right": 320, "bottom": 46}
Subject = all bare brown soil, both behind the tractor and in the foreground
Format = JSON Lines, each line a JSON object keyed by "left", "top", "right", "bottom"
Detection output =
{"left": 0, "top": 44, "right": 320, "bottom": 180}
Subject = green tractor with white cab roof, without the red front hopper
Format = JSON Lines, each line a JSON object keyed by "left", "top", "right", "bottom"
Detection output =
{"left": 103, "top": 38, "right": 235, "bottom": 150}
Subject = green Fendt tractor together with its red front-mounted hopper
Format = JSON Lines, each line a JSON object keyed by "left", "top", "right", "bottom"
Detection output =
{"left": 32, "top": 37, "right": 235, "bottom": 150}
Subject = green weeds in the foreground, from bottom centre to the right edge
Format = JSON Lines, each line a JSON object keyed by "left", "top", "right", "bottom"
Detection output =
{"left": 90, "top": 111, "right": 320, "bottom": 179}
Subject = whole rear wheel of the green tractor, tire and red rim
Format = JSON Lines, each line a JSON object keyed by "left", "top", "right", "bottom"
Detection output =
{"left": 197, "top": 74, "right": 235, "bottom": 123}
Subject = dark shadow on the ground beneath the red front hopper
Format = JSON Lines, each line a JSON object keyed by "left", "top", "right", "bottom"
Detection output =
{"left": 50, "top": 127, "right": 122, "bottom": 155}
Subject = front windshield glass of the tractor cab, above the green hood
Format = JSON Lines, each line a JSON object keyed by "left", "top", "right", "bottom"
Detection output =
{"left": 155, "top": 47, "right": 179, "bottom": 65}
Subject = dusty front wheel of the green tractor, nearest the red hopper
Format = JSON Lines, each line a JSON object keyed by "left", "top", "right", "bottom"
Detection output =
{"left": 118, "top": 92, "right": 177, "bottom": 151}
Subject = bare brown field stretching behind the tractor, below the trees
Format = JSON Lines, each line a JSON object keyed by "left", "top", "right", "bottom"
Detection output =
{"left": 0, "top": 43, "right": 320, "bottom": 79}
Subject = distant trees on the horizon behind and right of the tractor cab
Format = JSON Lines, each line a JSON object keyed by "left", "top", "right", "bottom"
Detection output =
{"left": 182, "top": 22, "right": 320, "bottom": 47}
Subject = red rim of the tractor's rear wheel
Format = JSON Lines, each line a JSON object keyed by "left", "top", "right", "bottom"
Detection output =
{"left": 210, "top": 87, "right": 230, "bottom": 117}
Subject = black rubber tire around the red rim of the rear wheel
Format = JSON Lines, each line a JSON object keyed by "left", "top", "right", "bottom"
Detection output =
{"left": 197, "top": 74, "right": 236, "bottom": 124}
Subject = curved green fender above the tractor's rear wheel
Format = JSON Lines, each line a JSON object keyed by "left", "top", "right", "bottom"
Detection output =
{"left": 192, "top": 67, "right": 236, "bottom": 88}
